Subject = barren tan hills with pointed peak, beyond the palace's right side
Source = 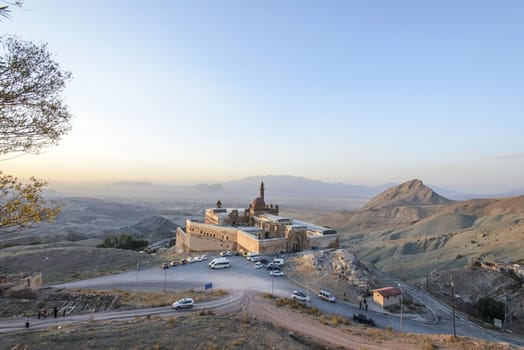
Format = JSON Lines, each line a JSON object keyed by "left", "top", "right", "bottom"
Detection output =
{"left": 298, "top": 180, "right": 524, "bottom": 279}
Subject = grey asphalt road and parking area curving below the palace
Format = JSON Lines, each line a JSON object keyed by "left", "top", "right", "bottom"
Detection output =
{"left": 0, "top": 252, "right": 524, "bottom": 346}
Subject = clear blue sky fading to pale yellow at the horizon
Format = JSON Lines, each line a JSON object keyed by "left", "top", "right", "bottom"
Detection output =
{"left": 0, "top": 0, "right": 524, "bottom": 193}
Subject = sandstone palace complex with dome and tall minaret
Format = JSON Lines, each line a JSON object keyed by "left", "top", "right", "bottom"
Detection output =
{"left": 176, "top": 182, "right": 339, "bottom": 254}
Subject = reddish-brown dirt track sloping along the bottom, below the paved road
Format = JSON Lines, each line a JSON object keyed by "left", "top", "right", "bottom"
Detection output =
{"left": 245, "top": 296, "right": 420, "bottom": 350}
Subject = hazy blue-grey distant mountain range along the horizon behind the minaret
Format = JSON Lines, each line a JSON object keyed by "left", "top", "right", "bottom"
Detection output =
{"left": 48, "top": 175, "right": 524, "bottom": 209}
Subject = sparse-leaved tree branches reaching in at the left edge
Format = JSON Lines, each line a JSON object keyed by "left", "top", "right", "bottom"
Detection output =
{"left": 0, "top": 22, "right": 71, "bottom": 233}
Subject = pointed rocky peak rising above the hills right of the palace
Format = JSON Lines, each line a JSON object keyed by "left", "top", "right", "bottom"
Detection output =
{"left": 363, "top": 180, "right": 452, "bottom": 209}
